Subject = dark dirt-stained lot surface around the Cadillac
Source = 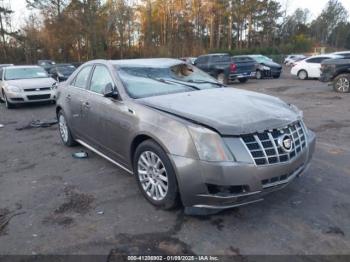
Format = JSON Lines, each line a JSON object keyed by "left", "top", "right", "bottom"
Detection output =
{"left": 0, "top": 68, "right": 350, "bottom": 261}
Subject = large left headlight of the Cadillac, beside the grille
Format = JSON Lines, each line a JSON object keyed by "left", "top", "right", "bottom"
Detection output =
{"left": 189, "top": 126, "right": 234, "bottom": 162}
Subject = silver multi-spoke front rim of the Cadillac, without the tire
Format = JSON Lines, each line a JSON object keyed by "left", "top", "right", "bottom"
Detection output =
{"left": 137, "top": 151, "right": 168, "bottom": 201}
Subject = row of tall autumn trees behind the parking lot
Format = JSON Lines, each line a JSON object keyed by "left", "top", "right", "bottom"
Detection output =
{"left": 0, "top": 0, "right": 350, "bottom": 63}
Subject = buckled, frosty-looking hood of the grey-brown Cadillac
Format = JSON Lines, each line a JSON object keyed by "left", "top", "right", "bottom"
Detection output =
{"left": 138, "top": 88, "right": 301, "bottom": 135}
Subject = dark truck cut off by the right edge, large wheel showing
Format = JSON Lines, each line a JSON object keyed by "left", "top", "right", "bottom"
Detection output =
{"left": 320, "top": 59, "right": 350, "bottom": 93}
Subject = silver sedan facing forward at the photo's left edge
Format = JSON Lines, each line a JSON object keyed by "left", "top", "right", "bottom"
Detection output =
{"left": 0, "top": 66, "right": 56, "bottom": 109}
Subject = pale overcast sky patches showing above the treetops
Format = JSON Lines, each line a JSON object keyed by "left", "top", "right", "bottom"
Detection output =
{"left": 4, "top": 0, "right": 350, "bottom": 28}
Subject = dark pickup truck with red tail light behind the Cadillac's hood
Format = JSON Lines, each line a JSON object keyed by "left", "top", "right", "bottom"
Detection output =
{"left": 194, "top": 53, "right": 255, "bottom": 84}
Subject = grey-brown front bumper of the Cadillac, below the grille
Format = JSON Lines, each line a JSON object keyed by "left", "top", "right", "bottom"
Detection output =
{"left": 169, "top": 130, "right": 316, "bottom": 210}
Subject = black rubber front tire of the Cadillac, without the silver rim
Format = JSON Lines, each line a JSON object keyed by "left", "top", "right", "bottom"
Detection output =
{"left": 133, "top": 140, "right": 180, "bottom": 210}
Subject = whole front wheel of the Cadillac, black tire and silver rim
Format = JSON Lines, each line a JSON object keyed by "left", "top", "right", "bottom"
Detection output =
{"left": 133, "top": 140, "right": 179, "bottom": 210}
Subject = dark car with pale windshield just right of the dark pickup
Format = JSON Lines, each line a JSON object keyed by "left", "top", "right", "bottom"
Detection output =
{"left": 249, "top": 55, "right": 282, "bottom": 79}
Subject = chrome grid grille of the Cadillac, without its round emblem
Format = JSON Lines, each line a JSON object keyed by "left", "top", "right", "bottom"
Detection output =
{"left": 241, "top": 121, "right": 306, "bottom": 166}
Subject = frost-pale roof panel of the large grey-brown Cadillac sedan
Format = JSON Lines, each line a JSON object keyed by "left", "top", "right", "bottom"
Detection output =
{"left": 109, "top": 58, "right": 184, "bottom": 68}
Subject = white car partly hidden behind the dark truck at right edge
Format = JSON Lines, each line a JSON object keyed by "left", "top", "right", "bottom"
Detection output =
{"left": 290, "top": 54, "right": 343, "bottom": 80}
